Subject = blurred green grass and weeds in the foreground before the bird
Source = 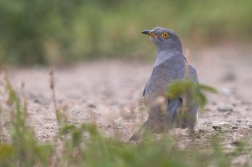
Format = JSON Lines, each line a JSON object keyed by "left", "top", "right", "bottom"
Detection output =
{"left": 0, "top": 72, "right": 250, "bottom": 167}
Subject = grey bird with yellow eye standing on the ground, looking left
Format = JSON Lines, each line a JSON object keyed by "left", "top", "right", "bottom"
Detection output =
{"left": 129, "top": 27, "right": 199, "bottom": 141}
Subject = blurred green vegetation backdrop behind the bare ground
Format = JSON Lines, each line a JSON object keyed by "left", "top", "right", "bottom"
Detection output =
{"left": 0, "top": 0, "right": 252, "bottom": 65}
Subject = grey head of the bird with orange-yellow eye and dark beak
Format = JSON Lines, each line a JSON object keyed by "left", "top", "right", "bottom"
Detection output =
{"left": 142, "top": 27, "right": 182, "bottom": 51}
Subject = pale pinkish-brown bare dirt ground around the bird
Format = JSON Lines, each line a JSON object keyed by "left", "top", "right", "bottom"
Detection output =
{"left": 0, "top": 47, "right": 252, "bottom": 163}
